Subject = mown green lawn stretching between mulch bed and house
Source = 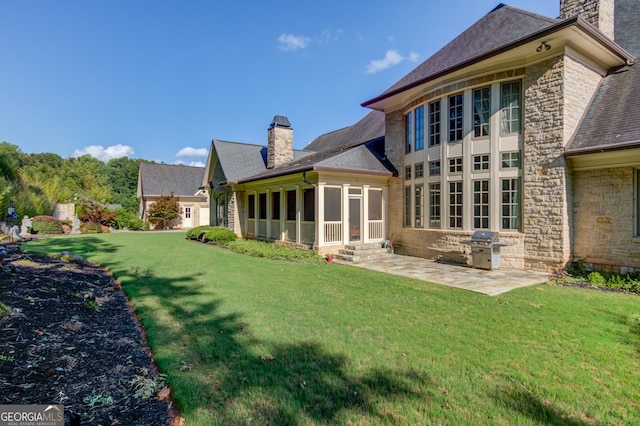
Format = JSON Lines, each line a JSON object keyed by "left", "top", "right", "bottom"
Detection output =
{"left": 26, "top": 233, "right": 640, "bottom": 425}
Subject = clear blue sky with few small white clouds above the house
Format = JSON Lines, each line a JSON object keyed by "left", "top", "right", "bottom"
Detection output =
{"left": 0, "top": 0, "right": 559, "bottom": 165}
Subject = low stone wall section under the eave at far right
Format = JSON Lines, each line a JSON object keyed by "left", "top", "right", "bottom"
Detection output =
{"left": 573, "top": 167, "right": 640, "bottom": 273}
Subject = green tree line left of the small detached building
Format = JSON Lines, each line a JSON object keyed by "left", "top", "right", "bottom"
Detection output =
{"left": 0, "top": 142, "right": 146, "bottom": 220}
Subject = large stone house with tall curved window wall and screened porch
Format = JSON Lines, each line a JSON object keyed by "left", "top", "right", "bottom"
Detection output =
{"left": 204, "top": 0, "right": 640, "bottom": 272}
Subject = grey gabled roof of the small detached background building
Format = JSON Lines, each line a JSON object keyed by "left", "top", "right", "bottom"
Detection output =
{"left": 138, "top": 163, "right": 204, "bottom": 197}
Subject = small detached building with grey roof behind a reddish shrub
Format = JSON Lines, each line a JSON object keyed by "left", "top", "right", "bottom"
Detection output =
{"left": 136, "top": 163, "right": 209, "bottom": 228}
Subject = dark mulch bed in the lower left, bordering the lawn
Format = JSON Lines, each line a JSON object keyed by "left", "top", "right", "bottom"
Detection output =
{"left": 0, "top": 245, "right": 174, "bottom": 425}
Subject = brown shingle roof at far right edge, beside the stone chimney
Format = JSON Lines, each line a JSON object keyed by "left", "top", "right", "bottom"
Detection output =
{"left": 565, "top": 0, "right": 640, "bottom": 154}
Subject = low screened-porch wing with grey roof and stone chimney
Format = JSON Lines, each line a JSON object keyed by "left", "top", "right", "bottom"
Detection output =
{"left": 203, "top": 111, "right": 397, "bottom": 253}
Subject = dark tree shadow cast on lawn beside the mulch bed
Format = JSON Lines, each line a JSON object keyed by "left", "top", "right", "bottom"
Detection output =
{"left": 132, "top": 278, "right": 442, "bottom": 424}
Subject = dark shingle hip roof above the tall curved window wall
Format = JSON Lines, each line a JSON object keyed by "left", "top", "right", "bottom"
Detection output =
{"left": 363, "top": 3, "right": 562, "bottom": 106}
